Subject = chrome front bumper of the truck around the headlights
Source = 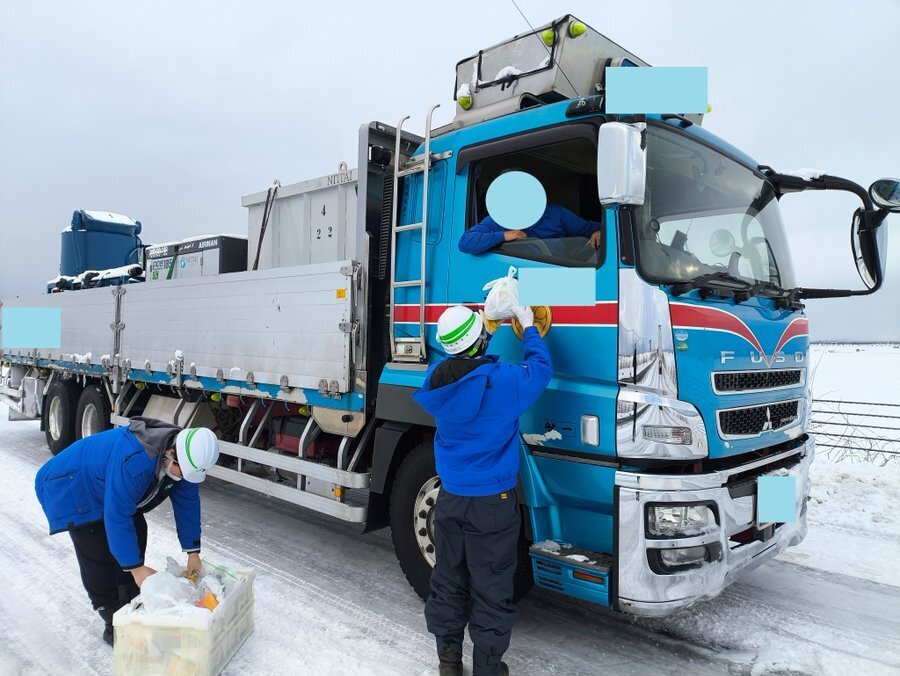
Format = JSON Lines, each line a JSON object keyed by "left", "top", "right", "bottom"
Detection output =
{"left": 615, "top": 437, "right": 815, "bottom": 617}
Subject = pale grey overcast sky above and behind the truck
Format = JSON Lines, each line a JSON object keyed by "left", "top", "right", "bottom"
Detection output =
{"left": 0, "top": 0, "right": 900, "bottom": 340}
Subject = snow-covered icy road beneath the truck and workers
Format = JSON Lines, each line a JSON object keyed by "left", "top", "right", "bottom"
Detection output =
{"left": 0, "top": 408, "right": 900, "bottom": 676}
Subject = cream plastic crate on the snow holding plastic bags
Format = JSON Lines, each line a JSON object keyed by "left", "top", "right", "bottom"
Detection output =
{"left": 113, "top": 560, "right": 255, "bottom": 676}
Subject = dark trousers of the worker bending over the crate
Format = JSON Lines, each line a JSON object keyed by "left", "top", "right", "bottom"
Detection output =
{"left": 69, "top": 513, "right": 147, "bottom": 616}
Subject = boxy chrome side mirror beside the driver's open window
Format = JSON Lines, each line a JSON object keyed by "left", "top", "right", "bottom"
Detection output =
{"left": 597, "top": 122, "right": 647, "bottom": 205}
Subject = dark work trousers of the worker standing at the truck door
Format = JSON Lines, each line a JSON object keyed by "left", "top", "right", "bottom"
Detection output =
{"left": 425, "top": 488, "right": 522, "bottom": 664}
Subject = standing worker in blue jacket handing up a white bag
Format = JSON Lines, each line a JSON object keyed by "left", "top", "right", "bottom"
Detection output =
{"left": 413, "top": 305, "right": 553, "bottom": 676}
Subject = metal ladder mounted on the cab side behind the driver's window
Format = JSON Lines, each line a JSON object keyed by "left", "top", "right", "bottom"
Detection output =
{"left": 388, "top": 104, "right": 443, "bottom": 363}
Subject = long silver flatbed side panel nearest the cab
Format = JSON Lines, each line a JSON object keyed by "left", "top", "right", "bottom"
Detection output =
{"left": 122, "top": 261, "right": 355, "bottom": 392}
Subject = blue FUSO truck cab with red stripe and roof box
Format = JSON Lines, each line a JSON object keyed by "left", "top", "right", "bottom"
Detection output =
{"left": 378, "top": 16, "right": 886, "bottom": 615}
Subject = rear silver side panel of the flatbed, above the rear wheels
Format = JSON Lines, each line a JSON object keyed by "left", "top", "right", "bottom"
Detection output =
{"left": 0, "top": 287, "right": 116, "bottom": 364}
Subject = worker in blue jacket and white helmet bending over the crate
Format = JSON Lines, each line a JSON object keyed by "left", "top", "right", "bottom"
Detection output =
{"left": 34, "top": 417, "right": 219, "bottom": 645}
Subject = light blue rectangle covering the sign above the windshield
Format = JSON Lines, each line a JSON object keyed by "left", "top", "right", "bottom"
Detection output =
{"left": 606, "top": 66, "right": 708, "bottom": 115}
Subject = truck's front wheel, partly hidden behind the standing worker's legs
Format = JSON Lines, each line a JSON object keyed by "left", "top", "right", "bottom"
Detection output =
{"left": 390, "top": 442, "right": 534, "bottom": 601}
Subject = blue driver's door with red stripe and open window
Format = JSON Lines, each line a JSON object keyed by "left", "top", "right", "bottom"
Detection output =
{"left": 448, "top": 123, "right": 618, "bottom": 457}
